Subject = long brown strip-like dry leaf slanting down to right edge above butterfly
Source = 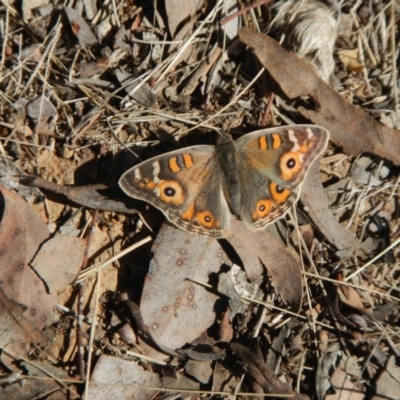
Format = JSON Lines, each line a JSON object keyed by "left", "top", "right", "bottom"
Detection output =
{"left": 239, "top": 28, "right": 400, "bottom": 165}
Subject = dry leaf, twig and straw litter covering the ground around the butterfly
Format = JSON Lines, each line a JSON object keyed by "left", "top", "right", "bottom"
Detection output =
{"left": 0, "top": 0, "right": 400, "bottom": 399}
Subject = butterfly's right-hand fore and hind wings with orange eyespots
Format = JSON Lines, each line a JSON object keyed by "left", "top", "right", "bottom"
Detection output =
{"left": 235, "top": 125, "right": 329, "bottom": 230}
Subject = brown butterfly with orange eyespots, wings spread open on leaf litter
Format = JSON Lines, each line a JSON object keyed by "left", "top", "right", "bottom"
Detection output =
{"left": 119, "top": 125, "right": 329, "bottom": 238}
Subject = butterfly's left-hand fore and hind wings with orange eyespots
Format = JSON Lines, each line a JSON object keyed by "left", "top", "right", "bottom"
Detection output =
{"left": 119, "top": 146, "right": 229, "bottom": 237}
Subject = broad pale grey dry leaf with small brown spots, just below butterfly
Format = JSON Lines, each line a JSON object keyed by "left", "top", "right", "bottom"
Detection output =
{"left": 140, "top": 224, "right": 226, "bottom": 358}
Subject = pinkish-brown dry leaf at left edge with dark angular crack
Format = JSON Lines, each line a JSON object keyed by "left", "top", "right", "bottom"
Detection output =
{"left": 0, "top": 188, "right": 84, "bottom": 329}
